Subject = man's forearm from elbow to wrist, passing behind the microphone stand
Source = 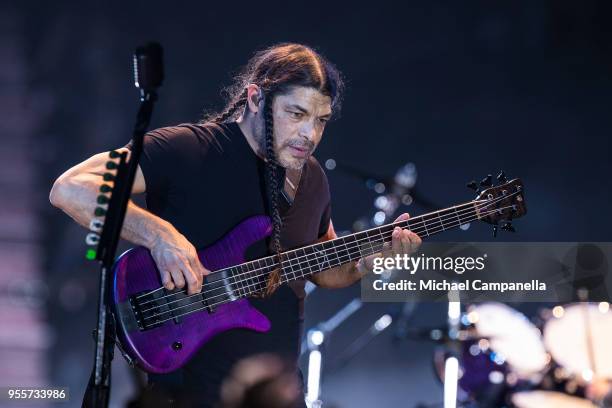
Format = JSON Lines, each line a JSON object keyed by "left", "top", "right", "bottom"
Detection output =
{"left": 50, "top": 172, "right": 171, "bottom": 248}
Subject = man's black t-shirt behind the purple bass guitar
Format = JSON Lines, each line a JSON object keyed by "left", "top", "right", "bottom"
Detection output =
{"left": 128, "top": 122, "right": 330, "bottom": 406}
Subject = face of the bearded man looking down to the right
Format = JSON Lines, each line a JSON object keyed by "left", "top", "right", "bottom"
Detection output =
{"left": 261, "top": 87, "right": 332, "bottom": 169}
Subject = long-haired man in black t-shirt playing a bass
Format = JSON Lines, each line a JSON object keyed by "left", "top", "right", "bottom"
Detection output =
{"left": 50, "top": 44, "right": 420, "bottom": 406}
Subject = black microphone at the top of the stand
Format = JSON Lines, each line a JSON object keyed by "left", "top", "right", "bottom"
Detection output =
{"left": 134, "top": 42, "right": 164, "bottom": 93}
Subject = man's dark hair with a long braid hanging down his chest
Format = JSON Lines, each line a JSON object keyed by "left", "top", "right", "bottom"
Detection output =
{"left": 201, "top": 43, "right": 344, "bottom": 295}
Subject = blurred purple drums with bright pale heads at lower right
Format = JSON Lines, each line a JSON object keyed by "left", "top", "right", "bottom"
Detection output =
{"left": 434, "top": 302, "right": 612, "bottom": 408}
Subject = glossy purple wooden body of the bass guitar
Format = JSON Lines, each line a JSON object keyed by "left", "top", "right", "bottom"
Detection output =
{"left": 112, "top": 216, "right": 272, "bottom": 373}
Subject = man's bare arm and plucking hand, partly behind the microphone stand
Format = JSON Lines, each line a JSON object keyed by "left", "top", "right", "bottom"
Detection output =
{"left": 49, "top": 148, "right": 209, "bottom": 293}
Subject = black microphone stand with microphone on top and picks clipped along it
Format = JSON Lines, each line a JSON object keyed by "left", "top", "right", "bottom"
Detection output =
{"left": 82, "top": 43, "right": 163, "bottom": 408}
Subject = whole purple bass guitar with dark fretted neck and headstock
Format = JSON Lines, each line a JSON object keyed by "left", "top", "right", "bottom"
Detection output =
{"left": 113, "top": 179, "right": 526, "bottom": 373}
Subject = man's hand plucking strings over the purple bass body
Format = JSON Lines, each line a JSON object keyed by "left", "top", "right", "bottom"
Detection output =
{"left": 149, "top": 226, "right": 210, "bottom": 294}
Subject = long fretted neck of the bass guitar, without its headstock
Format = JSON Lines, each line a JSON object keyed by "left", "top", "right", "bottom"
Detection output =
{"left": 230, "top": 201, "right": 482, "bottom": 297}
